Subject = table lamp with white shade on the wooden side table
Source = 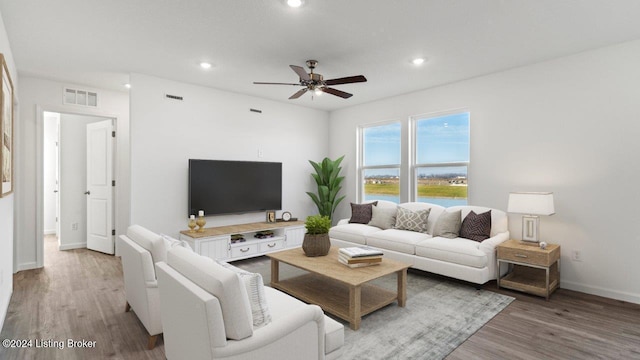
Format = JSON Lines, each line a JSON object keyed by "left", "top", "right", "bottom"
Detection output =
{"left": 507, "top": 192, "right": 555, "bottom": 244}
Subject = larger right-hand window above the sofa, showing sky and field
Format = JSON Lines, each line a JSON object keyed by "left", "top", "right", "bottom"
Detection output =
{"left": 412, "top": 112, "right": 469, "bottom": 207}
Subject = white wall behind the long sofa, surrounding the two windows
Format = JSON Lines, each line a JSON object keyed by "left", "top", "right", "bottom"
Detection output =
{"left": 329, "top": 41, "right": 640, "bottom": 303}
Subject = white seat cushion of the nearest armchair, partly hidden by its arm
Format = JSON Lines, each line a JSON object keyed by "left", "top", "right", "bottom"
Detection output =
{"left": 258, "top": 286, "right": 344, "bottom": 354}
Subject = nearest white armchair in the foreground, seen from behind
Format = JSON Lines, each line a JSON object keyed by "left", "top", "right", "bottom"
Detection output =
{"left": 156, "top": 247, "right": 344, "bottom": 360}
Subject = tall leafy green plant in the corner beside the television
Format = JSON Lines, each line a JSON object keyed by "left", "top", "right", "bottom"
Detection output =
{"left": 307, "top": 155, "right": 345, "bottom": 219}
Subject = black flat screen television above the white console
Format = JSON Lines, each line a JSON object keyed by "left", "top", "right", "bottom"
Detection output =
{"left": 188, "top": 159, "right": 282, "bottom": 216}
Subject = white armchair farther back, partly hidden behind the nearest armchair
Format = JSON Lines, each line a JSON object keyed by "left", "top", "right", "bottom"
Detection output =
{"left": 118, "top": 225, "right": 167, "bottom": 349}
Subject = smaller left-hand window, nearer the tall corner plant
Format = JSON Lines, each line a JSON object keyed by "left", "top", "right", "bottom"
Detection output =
{"left": 360, "top": 122, "right": 401, "bottom": 203}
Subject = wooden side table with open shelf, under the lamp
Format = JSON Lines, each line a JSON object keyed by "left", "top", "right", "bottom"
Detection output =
{"left": 496, "top": 240, "right": 560, "bottom": 301}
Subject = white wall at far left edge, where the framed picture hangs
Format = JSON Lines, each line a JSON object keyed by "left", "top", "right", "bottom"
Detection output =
{"left": 0, "top": 7, "right": 20, "bottom": 329}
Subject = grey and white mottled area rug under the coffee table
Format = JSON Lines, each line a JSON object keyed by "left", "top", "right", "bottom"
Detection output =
{"left": 234, "top": 257, "right": 514, "bottom": 360}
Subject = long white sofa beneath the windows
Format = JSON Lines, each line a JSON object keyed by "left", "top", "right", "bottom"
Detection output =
{"left": 329, "top": 200, "right": 509, "bottom": 287}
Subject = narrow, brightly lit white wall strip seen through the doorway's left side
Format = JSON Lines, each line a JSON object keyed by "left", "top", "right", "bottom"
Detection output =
{"left": 43, "top": 113, "right": 60, "bottom": 234}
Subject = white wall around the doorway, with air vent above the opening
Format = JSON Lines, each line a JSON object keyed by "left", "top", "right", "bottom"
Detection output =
{"left": 15, "top": 76, "right": 130, "bottom": 270}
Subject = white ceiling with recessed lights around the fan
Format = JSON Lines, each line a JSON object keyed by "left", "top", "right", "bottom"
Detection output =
{"left": 0, "top": 0, "right": 640, "bottom": 110}
